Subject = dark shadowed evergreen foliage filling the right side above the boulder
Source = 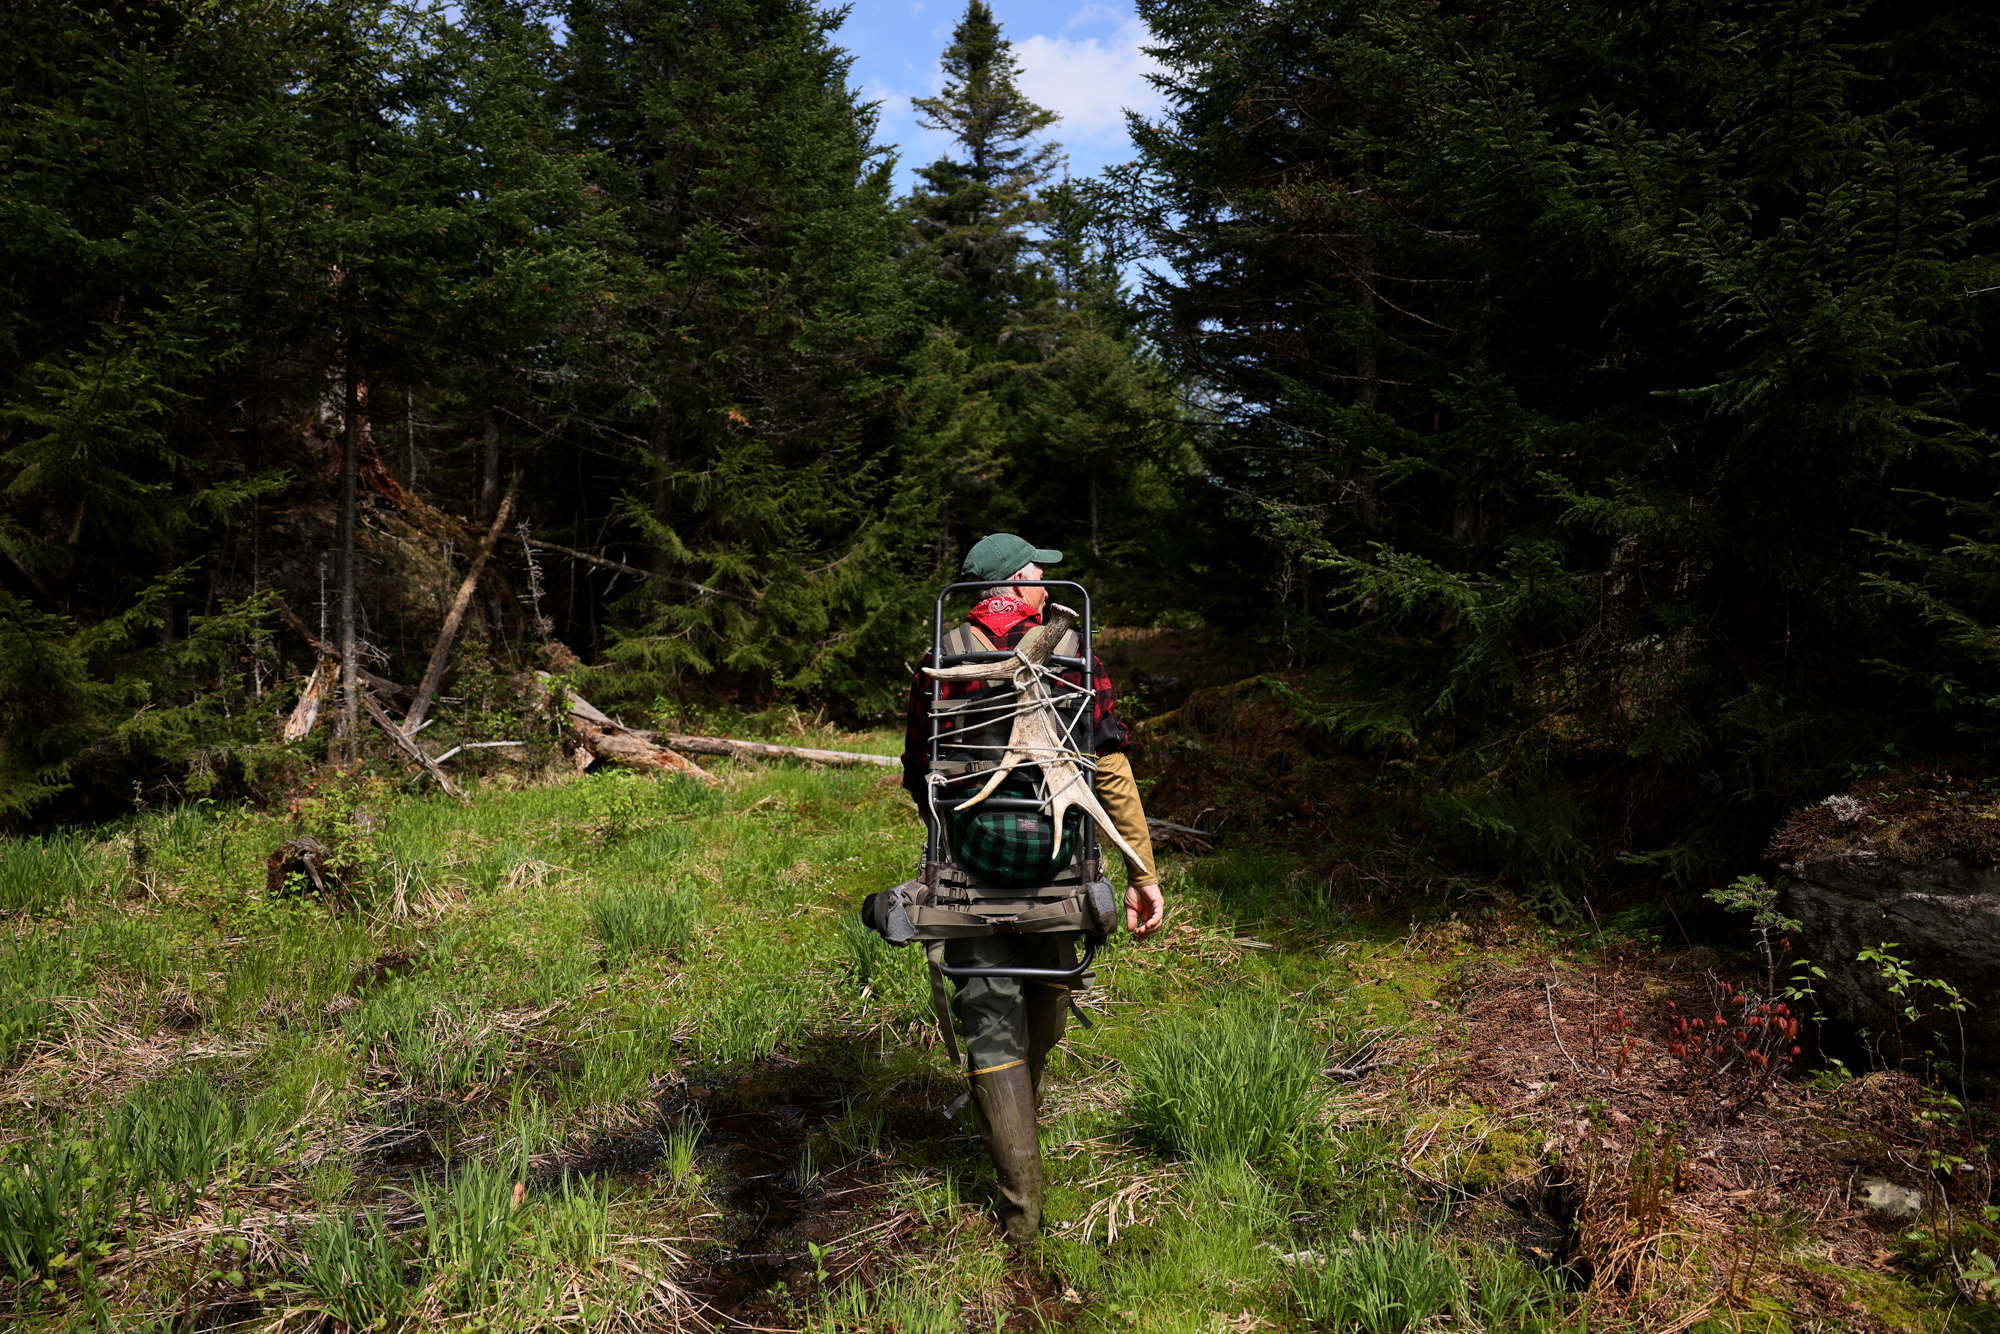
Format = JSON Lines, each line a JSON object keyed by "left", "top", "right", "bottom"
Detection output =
{"left": 1134, "top": 0, "right": 2000, "bottom": 908}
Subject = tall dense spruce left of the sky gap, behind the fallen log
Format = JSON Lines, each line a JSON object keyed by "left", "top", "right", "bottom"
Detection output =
{"left": 568, "top": 0, "right": 920, "bottom": 702}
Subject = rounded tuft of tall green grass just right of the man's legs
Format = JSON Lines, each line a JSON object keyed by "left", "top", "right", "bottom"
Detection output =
{"left": 1132, "top": 1012, "right": 1322, "bottom": 1162}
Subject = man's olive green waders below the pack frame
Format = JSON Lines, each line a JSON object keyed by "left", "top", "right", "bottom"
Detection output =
{"left": 944, "top": 934, "right": 1076, "bottom": 1246}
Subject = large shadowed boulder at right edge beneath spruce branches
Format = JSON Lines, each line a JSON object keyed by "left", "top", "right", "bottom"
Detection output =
{"left": 1770, "top": 764, "right": 2000, "bottom": 1084}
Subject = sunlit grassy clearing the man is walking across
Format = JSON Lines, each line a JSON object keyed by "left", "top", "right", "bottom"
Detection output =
{"left": 0, "top": 748, "right": 1972, "bottom": 1334}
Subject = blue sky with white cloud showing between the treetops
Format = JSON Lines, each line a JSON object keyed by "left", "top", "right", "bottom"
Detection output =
{"left": 834, "top": 0, "right": 1160, "bottom": 194}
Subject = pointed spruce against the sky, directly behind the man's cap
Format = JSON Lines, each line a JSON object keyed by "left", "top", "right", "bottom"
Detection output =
{"left": 902, "top": 0, "right": 1176, "bottom": 592}
